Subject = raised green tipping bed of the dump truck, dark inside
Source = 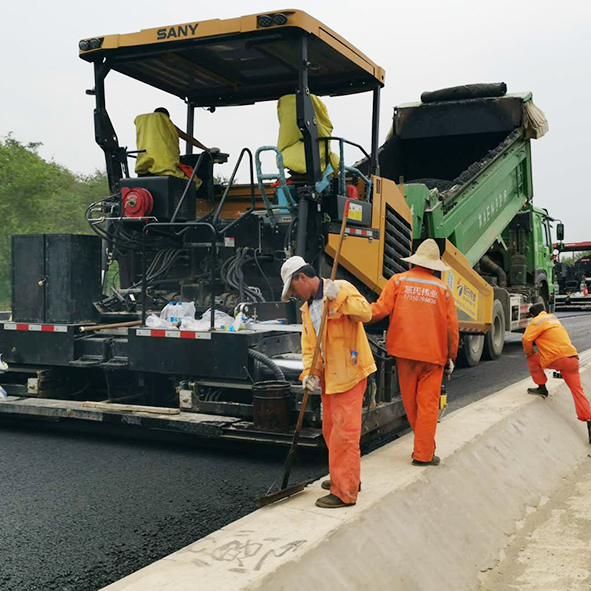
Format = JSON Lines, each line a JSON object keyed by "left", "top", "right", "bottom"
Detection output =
{"left": 380, "top": 93, "right": 547, "bottom": 265}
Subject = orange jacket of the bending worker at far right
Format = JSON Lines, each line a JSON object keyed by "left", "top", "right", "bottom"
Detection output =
{"left": 521, "top": 312, "right": 577, "bottom": 367}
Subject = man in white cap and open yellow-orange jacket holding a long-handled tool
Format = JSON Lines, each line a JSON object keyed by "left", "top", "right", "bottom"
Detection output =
{"left": 281, "top": 256, "right": 376, "bottom": 509}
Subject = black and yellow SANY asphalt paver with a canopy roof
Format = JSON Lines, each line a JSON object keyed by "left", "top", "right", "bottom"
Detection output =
{"left": 0, "top": 10, "right": 493, "bottom": 446}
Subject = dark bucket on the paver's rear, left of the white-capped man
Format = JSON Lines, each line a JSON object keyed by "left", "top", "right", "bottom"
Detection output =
{"left": 252, "top": 380, "right": 291, "bottom": 431}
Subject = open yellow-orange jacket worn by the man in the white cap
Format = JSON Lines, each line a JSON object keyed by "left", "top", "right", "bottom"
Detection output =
{"left": 300, "top": 280, "right": 377, "bottom": 394}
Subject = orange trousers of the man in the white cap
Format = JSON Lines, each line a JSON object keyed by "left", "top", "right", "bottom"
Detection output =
{"left": 322, "top": 378, "right": 367, "bottom": 503}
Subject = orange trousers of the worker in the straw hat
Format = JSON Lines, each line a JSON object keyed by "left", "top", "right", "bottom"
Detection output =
{"left": 396, "top": 358, "right": 443, "bottom": 462}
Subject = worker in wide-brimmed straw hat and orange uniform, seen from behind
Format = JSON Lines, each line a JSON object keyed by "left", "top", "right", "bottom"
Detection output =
{"left": 371, "top": 239, "right": 459, "bottom": 466}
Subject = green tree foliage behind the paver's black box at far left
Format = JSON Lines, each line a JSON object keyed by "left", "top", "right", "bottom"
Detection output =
{"left": 0, "top": 135, "right": 108, "bottom": 309}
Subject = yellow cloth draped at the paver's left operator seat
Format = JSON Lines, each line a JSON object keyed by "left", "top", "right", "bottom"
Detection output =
{"left": 134, "top": 113, "right": 187, "bottom": 179}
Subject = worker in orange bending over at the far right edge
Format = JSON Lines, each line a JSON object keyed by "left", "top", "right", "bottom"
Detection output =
{"left": 521, "top": 302, "right": 591, "bottom": 443}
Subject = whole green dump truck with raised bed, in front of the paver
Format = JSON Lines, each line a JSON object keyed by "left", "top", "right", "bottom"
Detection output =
{"left": 380, "top": 84, "right": 555, "bottom": 366}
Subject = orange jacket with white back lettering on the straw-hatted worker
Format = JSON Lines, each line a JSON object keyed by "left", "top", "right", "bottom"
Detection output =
{"left": 371, "top": 267, "right": 460, "bottom": 365}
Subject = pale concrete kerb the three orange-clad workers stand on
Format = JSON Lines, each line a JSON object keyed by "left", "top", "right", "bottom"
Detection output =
{"left": 105, "top": 354, "right": 591, "bottom": 591}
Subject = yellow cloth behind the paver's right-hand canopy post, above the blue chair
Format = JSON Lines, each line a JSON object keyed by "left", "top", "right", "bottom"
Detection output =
{"left": 277, "top": 94, "right": 339, "bottom": 174}
